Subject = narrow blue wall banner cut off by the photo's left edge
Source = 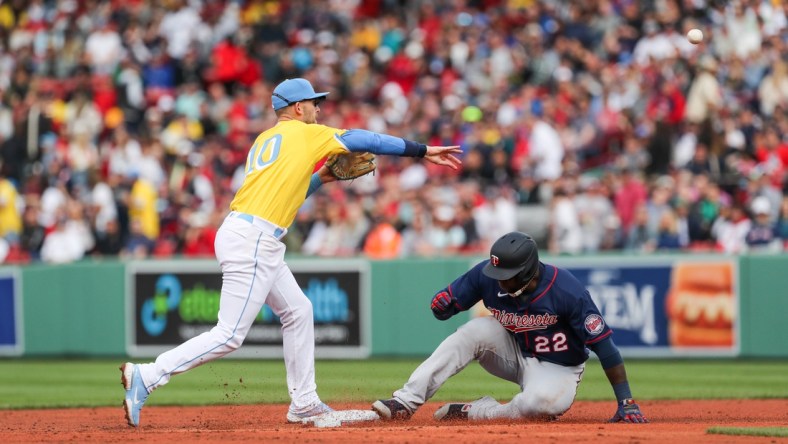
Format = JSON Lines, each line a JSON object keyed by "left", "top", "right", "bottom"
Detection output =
{"left": 0, "top": 268, "right": 24, "bottom": 356}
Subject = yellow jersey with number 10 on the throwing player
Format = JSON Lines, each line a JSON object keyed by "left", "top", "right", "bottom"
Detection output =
{"left": 230, "top": 120, "right": 348, "bottom": 228}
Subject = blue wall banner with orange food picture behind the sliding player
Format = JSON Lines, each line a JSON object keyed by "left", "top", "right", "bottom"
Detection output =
{"left": 474, "top": 256, "right": 740, "bottom": 357}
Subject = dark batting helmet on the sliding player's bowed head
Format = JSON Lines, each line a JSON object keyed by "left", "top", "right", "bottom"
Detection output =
{"left": 482, "top": 231, "right": 539, "bottom": 282}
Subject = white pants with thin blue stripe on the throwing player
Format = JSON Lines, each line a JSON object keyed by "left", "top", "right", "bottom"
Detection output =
{"left": 140, "top": 213, "right": 320, "bottom": 413}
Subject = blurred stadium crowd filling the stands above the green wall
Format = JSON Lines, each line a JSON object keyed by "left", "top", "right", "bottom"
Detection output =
{"left": 0, "top": 0, "right": 788, "bottom": 263}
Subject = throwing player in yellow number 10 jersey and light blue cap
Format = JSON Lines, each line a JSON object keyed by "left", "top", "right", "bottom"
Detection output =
{"left": 120, "top": 79, "right": 461, "bottom": 427}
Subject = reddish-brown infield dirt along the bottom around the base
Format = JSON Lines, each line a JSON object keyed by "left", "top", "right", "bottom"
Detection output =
{"left": 0, "top": 399, "right": 788, "bottom": 444}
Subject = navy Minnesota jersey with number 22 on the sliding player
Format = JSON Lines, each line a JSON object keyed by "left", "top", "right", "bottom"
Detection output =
{"left": 442, "top": 260, "right": 613, "bottom": 366}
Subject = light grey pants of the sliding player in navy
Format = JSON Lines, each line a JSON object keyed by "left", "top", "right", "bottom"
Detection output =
{"left": 394, "top": 316, "right": 585, "bottom": 419}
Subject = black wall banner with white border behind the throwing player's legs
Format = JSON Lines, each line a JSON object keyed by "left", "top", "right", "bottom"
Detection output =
{"left": 126, "top": 260, "right": 370, "bottom": 359}
